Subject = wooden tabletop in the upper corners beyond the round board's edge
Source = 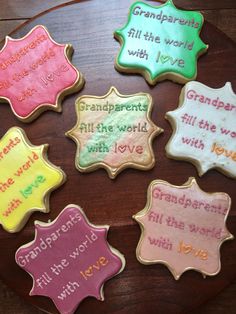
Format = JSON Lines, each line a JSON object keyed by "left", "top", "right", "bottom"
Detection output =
{"left": 0, "top": 0, "right": 236, "bottom": 41}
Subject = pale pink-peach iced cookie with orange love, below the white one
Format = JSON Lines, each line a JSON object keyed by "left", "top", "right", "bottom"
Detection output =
{"left": 133, "top": 178, "right": 233, "bottom": 280}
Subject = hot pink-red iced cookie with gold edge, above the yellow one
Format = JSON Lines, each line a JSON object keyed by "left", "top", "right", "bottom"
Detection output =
{"left": 0, "top": 25, "right": 84, "bottom": 122}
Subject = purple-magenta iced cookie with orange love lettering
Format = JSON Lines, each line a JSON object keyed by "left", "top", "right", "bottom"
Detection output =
{"left": 16, "top": 205, "right": 125, "bottom": 314}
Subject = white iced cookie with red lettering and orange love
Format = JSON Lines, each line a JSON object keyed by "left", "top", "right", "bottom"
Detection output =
{"left": 166, "top": 82, "right": 236, "bottom": 178}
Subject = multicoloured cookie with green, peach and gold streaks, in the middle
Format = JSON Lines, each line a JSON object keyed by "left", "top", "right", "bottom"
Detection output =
{"left": 66, "top": 87, "right": 162, "bottom": 178}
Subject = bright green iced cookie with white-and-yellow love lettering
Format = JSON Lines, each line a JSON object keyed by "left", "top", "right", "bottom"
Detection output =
{"left": 114, "top": 0, "right": 208, "bottom": 85}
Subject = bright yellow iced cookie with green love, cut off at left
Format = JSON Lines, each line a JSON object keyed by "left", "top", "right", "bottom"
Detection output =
{"left": 0, "top": 127, "right": 65, "bottom": 232}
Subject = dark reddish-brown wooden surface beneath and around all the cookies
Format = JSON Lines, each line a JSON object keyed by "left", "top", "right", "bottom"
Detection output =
{"left": 0, "top": 0, "right": 236, "bottom": 314}
